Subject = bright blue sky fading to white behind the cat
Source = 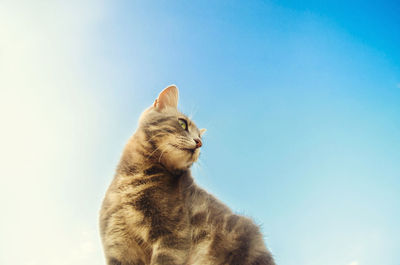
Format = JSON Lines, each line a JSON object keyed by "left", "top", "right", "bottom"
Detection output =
{"left": 0, "top": 0, "right": 400, "bottom": 265}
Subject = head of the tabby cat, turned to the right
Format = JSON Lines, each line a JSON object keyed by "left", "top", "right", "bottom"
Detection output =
{"left": 139, "top": 85, "right": 205, "bottom": 169}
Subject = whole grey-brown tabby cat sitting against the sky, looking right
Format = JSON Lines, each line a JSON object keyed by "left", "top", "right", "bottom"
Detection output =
{"left": 100, "top": 85, "right": 275, "bottom": 265}
